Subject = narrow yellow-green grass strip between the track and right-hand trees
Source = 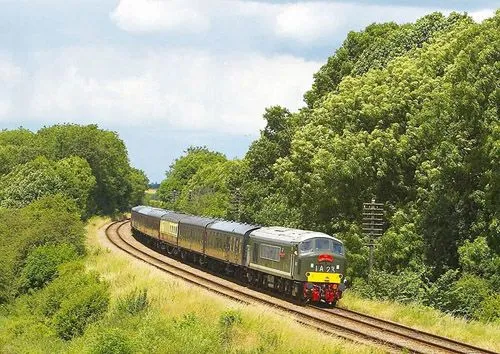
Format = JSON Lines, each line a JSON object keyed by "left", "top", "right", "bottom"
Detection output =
{"left": 340, "top": 291, "right": 500, "bottom": 352}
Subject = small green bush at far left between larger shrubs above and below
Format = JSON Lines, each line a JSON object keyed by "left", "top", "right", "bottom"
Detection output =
{"left": 19, "top": 244, "right": 78, "bottom": 292}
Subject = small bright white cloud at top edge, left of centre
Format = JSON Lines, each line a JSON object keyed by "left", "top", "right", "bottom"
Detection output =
{"left": 110, "top": 0, "right": 210, "bottom": 32}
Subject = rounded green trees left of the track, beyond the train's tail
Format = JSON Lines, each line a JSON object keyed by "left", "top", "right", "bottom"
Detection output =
{"left": 0, "top": 124, "right": 148, "bottom": 214}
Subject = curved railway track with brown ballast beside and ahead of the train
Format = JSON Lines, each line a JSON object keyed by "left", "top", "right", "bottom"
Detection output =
{"left": 106, "top": 220, "right": 495, "bottom": 354}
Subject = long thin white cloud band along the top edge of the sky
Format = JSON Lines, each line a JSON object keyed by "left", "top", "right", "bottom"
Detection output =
{"left": 110, "top": 0, "right": 446, "bottom": 46}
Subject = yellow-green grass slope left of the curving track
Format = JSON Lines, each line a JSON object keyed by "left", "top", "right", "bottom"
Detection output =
{"left": 80, "top": 219, "right": 382, "bottom": 353}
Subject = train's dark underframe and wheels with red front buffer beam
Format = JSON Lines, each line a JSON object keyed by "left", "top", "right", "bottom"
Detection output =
{"left": 132, "top": 229, "right": 342, "bottom": 306}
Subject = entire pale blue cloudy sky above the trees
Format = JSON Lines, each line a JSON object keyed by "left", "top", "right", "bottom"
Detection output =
{"left": 0, "top": 0, "right": 500, "bottom": 182}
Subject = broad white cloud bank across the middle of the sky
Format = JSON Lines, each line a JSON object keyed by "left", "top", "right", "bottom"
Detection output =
{"left": 7, "top": 48, "right": 321, "bottom": 134}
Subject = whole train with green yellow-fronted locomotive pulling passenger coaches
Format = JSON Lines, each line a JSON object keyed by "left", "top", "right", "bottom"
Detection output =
{"left": 131, "top": 205, "right": 346, "bottom": 306}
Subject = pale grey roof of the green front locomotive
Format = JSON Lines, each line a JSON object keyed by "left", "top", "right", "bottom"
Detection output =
{"left": 250, "top": 226, "right": 342, "bottom": 244}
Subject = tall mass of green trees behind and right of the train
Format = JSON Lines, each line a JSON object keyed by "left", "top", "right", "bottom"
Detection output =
{"left": 158, "top": 11, "right": 500, "bottom": 319}
